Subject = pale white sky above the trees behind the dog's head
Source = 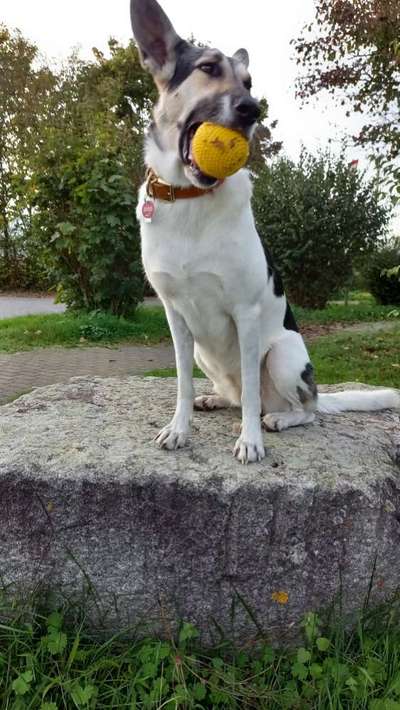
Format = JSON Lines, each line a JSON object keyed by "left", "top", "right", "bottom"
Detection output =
{"left": 0, "top": 0, "right": 400, "bottom": 231}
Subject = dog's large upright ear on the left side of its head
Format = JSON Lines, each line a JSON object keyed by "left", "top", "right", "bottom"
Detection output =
{"left": 131, "top": 0, "right": 180, "bottom": 83}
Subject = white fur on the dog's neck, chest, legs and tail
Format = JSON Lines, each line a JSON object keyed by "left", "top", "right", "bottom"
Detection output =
{"left": 138, "top": 161, "right": 400, "bottom": 463}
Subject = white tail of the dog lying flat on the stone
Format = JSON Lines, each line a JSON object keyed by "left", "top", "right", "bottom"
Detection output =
{"left": 317, "top": 389, "right": 400, "bottom": 414}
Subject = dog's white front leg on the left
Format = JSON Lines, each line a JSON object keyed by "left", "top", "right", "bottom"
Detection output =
{"left": 156, "top": 304, "right": 194, "bottom": 450}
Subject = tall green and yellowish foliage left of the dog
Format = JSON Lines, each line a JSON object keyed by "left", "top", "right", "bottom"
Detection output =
{"left": 0, "top": 32, "right": 155, "bottom": 314}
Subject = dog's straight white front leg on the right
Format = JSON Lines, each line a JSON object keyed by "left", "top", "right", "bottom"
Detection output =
{"left": 233, "top": 309, "right": 265, "bottom": 463}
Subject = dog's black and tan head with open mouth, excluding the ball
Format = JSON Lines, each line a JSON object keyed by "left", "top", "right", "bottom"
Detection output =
{"left": 131, "top": 0, "right": 260, "bottom": 188}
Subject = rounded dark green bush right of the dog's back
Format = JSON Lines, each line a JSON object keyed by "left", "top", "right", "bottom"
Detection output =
{"left": 253, "top": 150, "right": 389, "bottom": 308}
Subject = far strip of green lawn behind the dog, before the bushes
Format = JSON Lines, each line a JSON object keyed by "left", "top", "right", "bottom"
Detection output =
{"left": 0, "top": 301, "right": 397, "bottom": 353}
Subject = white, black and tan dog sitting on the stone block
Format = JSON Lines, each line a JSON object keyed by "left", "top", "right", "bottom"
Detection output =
{"left": 131, "top": 0, "right": 400, "bottom": 463}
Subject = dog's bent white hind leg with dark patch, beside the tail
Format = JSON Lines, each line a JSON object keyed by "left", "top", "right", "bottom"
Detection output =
{"left": 261, "top": 331, "right": 317, "bottom": 431}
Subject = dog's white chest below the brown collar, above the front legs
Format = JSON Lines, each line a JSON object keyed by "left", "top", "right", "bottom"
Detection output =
{"left": 138, "top": 176, "right": 266, "bottom": 341}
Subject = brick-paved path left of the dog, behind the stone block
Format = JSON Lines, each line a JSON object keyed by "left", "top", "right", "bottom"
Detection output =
{"left": 0, "top": 345, "right": 175, "bottom": 404}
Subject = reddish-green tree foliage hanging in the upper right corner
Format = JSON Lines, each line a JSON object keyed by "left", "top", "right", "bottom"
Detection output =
{"left": 295, "top": 0, "right": 400, "bottom": 196}
